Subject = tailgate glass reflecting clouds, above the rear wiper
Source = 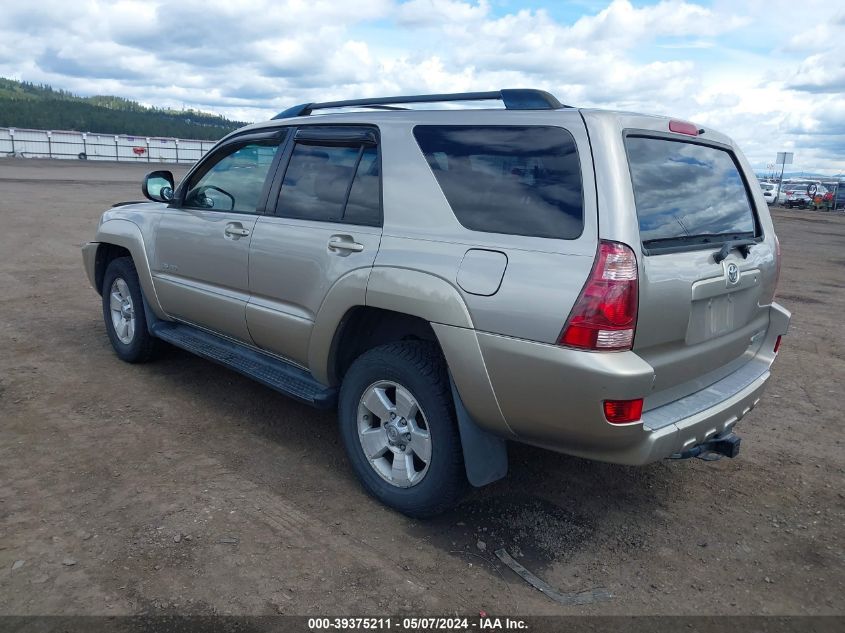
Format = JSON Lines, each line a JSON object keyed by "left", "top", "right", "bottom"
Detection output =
{"left": 625, "top": 136, "right": 756, "bottom": 247}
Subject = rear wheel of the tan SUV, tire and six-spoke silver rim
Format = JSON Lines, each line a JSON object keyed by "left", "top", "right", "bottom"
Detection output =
{"left": 338, "top": 341, "right": 467, "bottom": 518}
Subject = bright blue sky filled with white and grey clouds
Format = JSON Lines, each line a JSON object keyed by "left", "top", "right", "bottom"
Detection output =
{"left": 0, "top": 0, "right": 845, "bottom": 174}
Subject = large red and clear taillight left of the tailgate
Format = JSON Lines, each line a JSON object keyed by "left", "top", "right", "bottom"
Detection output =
{"left": 558, "top": 241, "right": 638, "bottom": 351}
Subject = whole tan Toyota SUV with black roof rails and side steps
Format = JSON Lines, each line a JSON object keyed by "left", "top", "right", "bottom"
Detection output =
{"left": 82, "top": 90, "right": 790, "bottom": 516}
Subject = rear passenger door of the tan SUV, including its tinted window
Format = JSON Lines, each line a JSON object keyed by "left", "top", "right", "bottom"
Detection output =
{"left": 246, "top": 126, "right": 382, "bottom": 367}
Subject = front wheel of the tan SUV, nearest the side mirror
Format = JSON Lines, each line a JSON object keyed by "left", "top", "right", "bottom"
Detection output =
{"left": 102, "top": 257, "right": 160, "bottom": 363}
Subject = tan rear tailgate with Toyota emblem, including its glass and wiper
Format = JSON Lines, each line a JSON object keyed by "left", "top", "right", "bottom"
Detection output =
{"left": 625, "top": 135, "right": 777, "bottom": 407}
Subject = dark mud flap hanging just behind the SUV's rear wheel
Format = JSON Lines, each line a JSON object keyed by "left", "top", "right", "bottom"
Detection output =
{"left": 449, "top": 376, "right": 508, "bottom": 488}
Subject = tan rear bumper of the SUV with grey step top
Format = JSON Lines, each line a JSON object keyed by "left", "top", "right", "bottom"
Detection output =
{"left": 472, "top": 304, "right": 790, "bottom": 465}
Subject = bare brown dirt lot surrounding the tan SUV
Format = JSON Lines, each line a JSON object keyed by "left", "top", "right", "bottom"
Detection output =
{"left": 0, "top": 159, "right": 845, "bottom": 615}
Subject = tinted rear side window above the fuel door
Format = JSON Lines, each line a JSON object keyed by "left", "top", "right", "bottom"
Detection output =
{"left": 414, "top": 125, "right": 584, "bottom": 239}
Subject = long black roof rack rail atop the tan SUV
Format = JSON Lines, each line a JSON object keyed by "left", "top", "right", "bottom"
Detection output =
{"left": 273, "top": 88, "right": 570, "bottom": 119}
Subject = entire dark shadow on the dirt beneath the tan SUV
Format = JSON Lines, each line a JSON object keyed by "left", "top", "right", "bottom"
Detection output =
{"left": 125, "top": 346, "right": 694, "bottom": 573}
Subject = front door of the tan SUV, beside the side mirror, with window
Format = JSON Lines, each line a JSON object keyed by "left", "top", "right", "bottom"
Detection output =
{"left": 152, "top": 131, "right": 285, "bottom": 342}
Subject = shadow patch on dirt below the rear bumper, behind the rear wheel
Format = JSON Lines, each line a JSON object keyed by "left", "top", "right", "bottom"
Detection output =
{"left": 412, "top": 443, "right": 688, "bottom": 571}
